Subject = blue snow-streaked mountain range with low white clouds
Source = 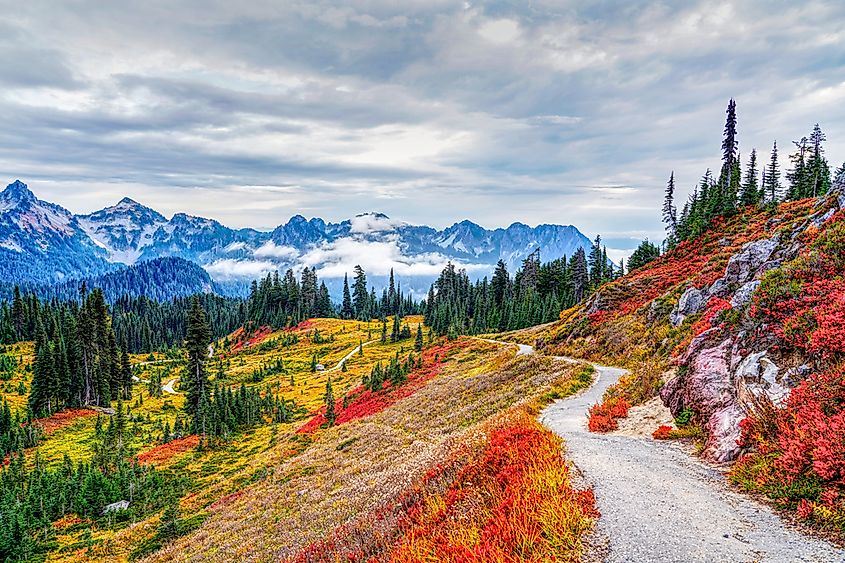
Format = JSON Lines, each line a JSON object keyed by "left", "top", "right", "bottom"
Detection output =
{"left": 0, "top": 180, "right": 590, "bottom": 294}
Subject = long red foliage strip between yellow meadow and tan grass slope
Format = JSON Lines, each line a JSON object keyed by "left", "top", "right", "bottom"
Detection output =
{"left": 297, "top": 340, "right": 464, "bottom": 434}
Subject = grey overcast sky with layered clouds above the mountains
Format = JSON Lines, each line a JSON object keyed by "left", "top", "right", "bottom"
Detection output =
{"left": 0, "top": 0, "right": 845, "bottom": 253}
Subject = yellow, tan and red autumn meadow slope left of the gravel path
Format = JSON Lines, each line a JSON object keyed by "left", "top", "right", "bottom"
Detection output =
{"left": 0, "top": 317, "right": 596, "bottom": 561}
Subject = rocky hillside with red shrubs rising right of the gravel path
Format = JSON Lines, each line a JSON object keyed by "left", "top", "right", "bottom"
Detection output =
{"left": 524, "top": 185, "right": 845, "bottom": 534}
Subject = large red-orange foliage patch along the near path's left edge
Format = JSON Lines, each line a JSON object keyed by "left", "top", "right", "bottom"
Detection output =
{"left": 295, "top": 414, "right": 598, "bottom": 563}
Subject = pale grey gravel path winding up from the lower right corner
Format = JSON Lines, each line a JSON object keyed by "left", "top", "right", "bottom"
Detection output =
{"left": 482, "top": 341, "right": 845, "bottom": 563}
